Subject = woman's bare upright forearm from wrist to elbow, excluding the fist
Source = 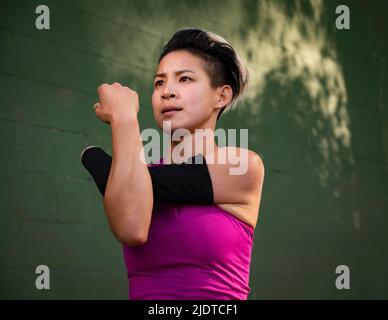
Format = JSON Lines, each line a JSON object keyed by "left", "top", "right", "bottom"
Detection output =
{"left": 103, "top": 119, "right": 153, "bottom": 245}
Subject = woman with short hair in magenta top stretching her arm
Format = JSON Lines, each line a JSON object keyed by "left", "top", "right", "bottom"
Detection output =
{"left": 87, "top": 28, "right": 264, "bottom": 300}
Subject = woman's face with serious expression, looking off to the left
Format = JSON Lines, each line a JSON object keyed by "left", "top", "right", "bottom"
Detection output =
{"left": 152, "top": 50, "right": 220, "bottom": 132}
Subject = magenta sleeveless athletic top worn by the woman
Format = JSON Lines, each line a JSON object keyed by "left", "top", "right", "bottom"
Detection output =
{"left": 123, "top": 159, "right": 254, "bottom": 300}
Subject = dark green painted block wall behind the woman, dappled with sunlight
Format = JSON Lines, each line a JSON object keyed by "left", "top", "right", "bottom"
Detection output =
{"left": 0, "top": 0, "right": 388, "bottom": 299}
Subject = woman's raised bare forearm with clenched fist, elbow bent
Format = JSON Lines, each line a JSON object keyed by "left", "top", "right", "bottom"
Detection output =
{"left": 94, "top": 82, "right": 153, "bottom": 245}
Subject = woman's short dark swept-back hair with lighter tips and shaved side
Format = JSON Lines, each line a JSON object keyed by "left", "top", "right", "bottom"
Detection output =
{"left": 158, "top": 28, "right": 249, "bottom": 120}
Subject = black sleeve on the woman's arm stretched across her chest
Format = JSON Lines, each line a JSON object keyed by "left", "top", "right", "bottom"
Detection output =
{"left": 81, "top": 146, "right": 214, "bottom": 204}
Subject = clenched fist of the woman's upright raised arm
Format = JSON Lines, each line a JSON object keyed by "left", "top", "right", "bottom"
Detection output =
{"left": 94, "top": 82, "right": 139, "bottom": 124}
